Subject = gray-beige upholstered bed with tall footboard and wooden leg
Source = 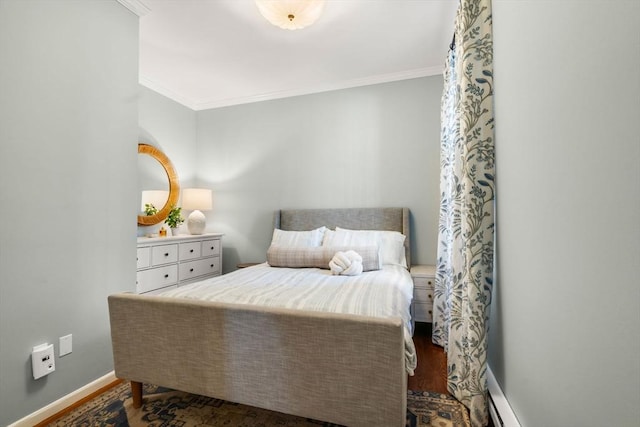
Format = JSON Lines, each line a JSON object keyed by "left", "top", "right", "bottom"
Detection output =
{"left": 109, "top": 208, "right": 415, "bottom": 426}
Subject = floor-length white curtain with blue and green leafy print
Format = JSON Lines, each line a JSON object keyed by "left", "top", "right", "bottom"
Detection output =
{"left": 433, "top": 0, "right": 495, "bottom": 426}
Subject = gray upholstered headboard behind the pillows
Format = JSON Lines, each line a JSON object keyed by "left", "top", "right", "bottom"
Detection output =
{"left": 273, "top": 208, "right": 411, "bottom": 266}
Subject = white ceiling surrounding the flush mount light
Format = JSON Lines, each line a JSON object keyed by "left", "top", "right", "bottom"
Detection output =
{"left": 140, "top": 0, "right": 458, "bottom": 110}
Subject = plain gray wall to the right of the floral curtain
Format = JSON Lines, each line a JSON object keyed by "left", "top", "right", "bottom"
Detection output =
{"left": 489, "top": 0, "right": 640, "bottom": 427}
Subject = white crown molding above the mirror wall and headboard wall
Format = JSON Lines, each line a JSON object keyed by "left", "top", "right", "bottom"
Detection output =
{"left": 139, "top": 67, "right": 443, "bottom": 111}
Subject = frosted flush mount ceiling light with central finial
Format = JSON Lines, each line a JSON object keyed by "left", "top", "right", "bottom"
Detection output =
{"left": 256, "top": 0, "right": 325, "bottom": 30}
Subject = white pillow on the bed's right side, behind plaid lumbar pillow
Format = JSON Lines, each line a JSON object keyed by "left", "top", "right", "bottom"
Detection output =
{"left": 322, "top": 227, "right": 407, "bottom": 268}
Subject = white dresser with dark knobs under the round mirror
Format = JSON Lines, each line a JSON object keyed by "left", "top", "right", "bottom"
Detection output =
{"left": 136, "top": 233, "right": 222, "bottom": 294}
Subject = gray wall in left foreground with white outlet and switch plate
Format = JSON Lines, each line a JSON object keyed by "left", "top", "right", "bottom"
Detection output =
{"left": 0, "top": 0, "right": 138, "bottom": 425}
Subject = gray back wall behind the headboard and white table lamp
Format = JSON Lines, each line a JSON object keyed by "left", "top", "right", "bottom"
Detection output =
{"left": 197, "top": 76, "right": 442, "bottom": 271}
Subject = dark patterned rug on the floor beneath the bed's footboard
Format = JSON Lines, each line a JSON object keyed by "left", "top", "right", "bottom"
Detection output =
{"left": 49, "top": 383, "right": 470, "bottom": 427}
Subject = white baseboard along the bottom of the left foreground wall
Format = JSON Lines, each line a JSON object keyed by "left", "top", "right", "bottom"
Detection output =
{"left": 8, "top": 371, "right": 121, "bottom": 427}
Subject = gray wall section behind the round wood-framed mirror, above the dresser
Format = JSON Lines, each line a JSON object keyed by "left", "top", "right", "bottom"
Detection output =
{"left": 138, "top": 86, "right": 197, "bottom": 236}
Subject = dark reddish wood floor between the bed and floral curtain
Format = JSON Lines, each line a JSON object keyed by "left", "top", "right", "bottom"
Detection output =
{"left": 408, "top": 323, "right": 448, "bottom": 394}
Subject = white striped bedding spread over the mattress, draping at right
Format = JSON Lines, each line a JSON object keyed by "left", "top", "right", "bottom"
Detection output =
{"left": 160, "top": 263, "right": 416, "bottom": 375}
